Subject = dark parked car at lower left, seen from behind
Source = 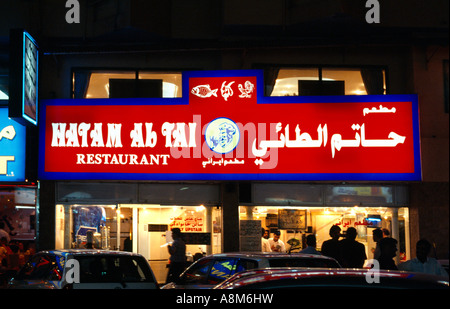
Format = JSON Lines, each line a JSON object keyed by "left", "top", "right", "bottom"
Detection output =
{"left": 7, "top": 249, "right": 159, "bottom": 289}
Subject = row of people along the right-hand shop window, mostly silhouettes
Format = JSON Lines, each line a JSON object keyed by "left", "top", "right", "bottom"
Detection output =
{"left": 261, "top": 225, "right": 449, "bottom": 277}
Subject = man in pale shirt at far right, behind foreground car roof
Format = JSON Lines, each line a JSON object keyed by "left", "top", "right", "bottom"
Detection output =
{"left": 398, "top": 239, "right": 448, "bottom": 278}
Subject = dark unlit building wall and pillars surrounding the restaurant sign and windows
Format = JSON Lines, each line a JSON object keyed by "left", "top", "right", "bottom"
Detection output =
{"left": 0, "top": 0, "right": 449, "bottom": 256}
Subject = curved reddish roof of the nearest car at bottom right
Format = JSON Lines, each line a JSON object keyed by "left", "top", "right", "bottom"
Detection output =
{"left": 215, "top": 268, "right": 449, "bottom": 289}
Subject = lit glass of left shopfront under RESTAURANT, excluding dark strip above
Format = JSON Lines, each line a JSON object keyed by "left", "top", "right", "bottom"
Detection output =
{"left": 55, "top": 204, "right": 222, "bottom": 282}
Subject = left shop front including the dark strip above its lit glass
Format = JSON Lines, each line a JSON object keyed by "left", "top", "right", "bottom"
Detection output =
{"left": 55, "top": 182, "right": 222, "bottom": 282}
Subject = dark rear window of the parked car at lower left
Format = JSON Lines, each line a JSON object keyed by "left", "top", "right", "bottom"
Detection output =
{"left": 76, "top": 256, "right": 154, "bottom": 283}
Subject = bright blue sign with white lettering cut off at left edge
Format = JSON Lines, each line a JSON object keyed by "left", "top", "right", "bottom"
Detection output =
{"left": 0, "top": 108, "right": 26, "bottom": 182}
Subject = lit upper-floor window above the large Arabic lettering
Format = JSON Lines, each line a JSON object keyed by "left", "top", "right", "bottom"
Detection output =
{"left": 266, "top": 67, "right": 386, "bottom": 96}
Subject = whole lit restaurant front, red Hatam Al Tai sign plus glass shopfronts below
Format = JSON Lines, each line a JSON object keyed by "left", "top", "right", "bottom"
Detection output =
{"left": 39, "top": 70, "right": 421, "bottom": 281}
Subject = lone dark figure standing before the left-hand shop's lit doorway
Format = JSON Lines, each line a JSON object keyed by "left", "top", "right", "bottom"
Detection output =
{"left": 166, "top": 228, "right": 186, "bottom": 283}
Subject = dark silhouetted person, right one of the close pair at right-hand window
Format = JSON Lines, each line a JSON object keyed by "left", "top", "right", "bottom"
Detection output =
{"left": 338, "top": 227, "right": 367, "bottom": 268}
